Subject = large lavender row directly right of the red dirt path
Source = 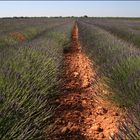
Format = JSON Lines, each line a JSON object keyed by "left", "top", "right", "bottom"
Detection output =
{"left": 78, "top": 19, "right": 140, "bottom": 140}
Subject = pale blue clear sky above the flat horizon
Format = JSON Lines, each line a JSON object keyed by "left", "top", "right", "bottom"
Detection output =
{"left": 0, "top": 1, "right": 140, "bottom": 17}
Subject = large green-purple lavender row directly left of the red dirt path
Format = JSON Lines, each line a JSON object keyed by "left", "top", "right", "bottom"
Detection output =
{"left": 0, "top": 20, "right": 73, "bottom": 140}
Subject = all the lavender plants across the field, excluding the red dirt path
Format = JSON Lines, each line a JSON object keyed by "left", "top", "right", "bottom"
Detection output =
{"left": 0, "top": 17, "right": 140, "bottom": 140}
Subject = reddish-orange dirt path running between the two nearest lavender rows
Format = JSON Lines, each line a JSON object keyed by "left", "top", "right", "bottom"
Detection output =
{"left": 51, "top": 25, "right": 122, "bottom": 140}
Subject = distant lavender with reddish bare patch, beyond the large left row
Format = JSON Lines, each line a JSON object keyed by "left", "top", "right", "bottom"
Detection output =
{"left": 0, "top": 18, "right": 70, "bottom": 50}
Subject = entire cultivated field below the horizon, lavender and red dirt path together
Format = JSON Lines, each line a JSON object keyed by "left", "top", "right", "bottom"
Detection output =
{"left": 0, "top": 17, "right": 140, "bottom": 140}
